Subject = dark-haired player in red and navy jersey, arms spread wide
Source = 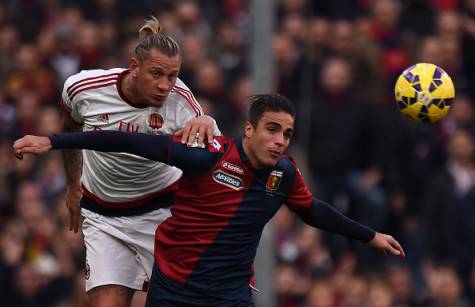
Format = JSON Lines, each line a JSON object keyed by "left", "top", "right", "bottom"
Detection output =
{"left": 14, "top": 95, "right": 405, "bottom": 307}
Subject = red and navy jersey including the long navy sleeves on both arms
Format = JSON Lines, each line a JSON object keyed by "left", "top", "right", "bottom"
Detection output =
{"left": 50, "top": 131, "right": 375, "bottom": 301}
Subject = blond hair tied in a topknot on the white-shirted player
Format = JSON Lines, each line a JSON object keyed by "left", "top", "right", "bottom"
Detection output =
{"left": 135, "top": 16, "right": 180, "bottom": 62}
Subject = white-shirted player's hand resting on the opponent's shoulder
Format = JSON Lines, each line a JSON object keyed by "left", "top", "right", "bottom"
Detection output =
{"left": 175, "top": 115, "right": 214, "bottom": 147}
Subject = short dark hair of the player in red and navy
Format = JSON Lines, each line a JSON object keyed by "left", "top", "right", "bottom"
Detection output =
{"left": 248, "top": 94, "right": 295, "bottom": 127}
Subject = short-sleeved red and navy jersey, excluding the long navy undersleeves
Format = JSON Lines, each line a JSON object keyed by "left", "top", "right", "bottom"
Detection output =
{"left": 155, "top": 137, "right": 313, "bottom": 298}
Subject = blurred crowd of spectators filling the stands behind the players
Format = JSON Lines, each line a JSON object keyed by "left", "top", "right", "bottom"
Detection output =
{"left": 0, "top": 0, "right": 475, "bottom": 307}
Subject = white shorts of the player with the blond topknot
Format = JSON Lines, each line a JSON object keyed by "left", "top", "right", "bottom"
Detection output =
{"left": 81, "top": 208, "right": 171, "bottom": 292}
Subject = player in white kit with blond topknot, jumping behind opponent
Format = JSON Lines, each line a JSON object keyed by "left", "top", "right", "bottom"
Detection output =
{"left": 62, "top": 17, "right": 219, "bottom": 307}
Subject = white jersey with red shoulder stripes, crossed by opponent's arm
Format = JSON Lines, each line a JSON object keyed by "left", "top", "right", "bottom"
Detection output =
{"left": 62, "top": 68, "right": 205, "bottom": 206}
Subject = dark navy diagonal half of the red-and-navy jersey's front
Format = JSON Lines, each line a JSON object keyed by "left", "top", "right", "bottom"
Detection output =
{"left": 185, "top": 157, "right": 296, "bottom": 302}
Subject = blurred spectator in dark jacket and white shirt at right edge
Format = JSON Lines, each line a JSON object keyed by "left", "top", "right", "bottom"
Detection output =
{"left": 423, "top": 131, "right": 475, "bottom": 283}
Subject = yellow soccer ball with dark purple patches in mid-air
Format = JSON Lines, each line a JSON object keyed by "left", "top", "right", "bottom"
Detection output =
{"left": 394, "top": 63, "right": 455, "bottom": 123}
